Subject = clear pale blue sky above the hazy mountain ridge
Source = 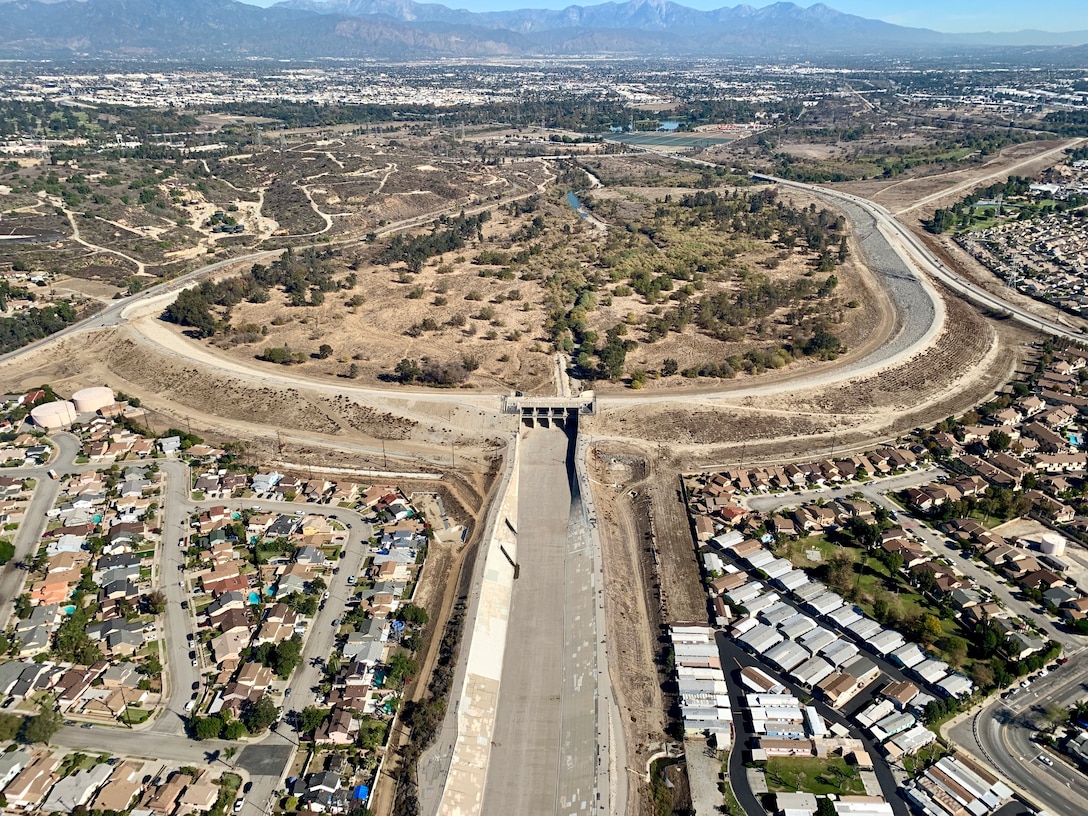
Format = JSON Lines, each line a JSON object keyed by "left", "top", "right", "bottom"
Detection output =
{"left": 244, "top": 0, "right": 1088, "bottom": 33}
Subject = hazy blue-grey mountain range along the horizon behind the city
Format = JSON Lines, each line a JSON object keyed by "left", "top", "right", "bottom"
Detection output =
{"left": 0, "top": 0, "right": 1088, "bottom": 61}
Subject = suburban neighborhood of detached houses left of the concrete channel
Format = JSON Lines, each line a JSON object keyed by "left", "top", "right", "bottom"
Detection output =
{"left": 0, "top": 388, "right": 446, "bottom": 816}
